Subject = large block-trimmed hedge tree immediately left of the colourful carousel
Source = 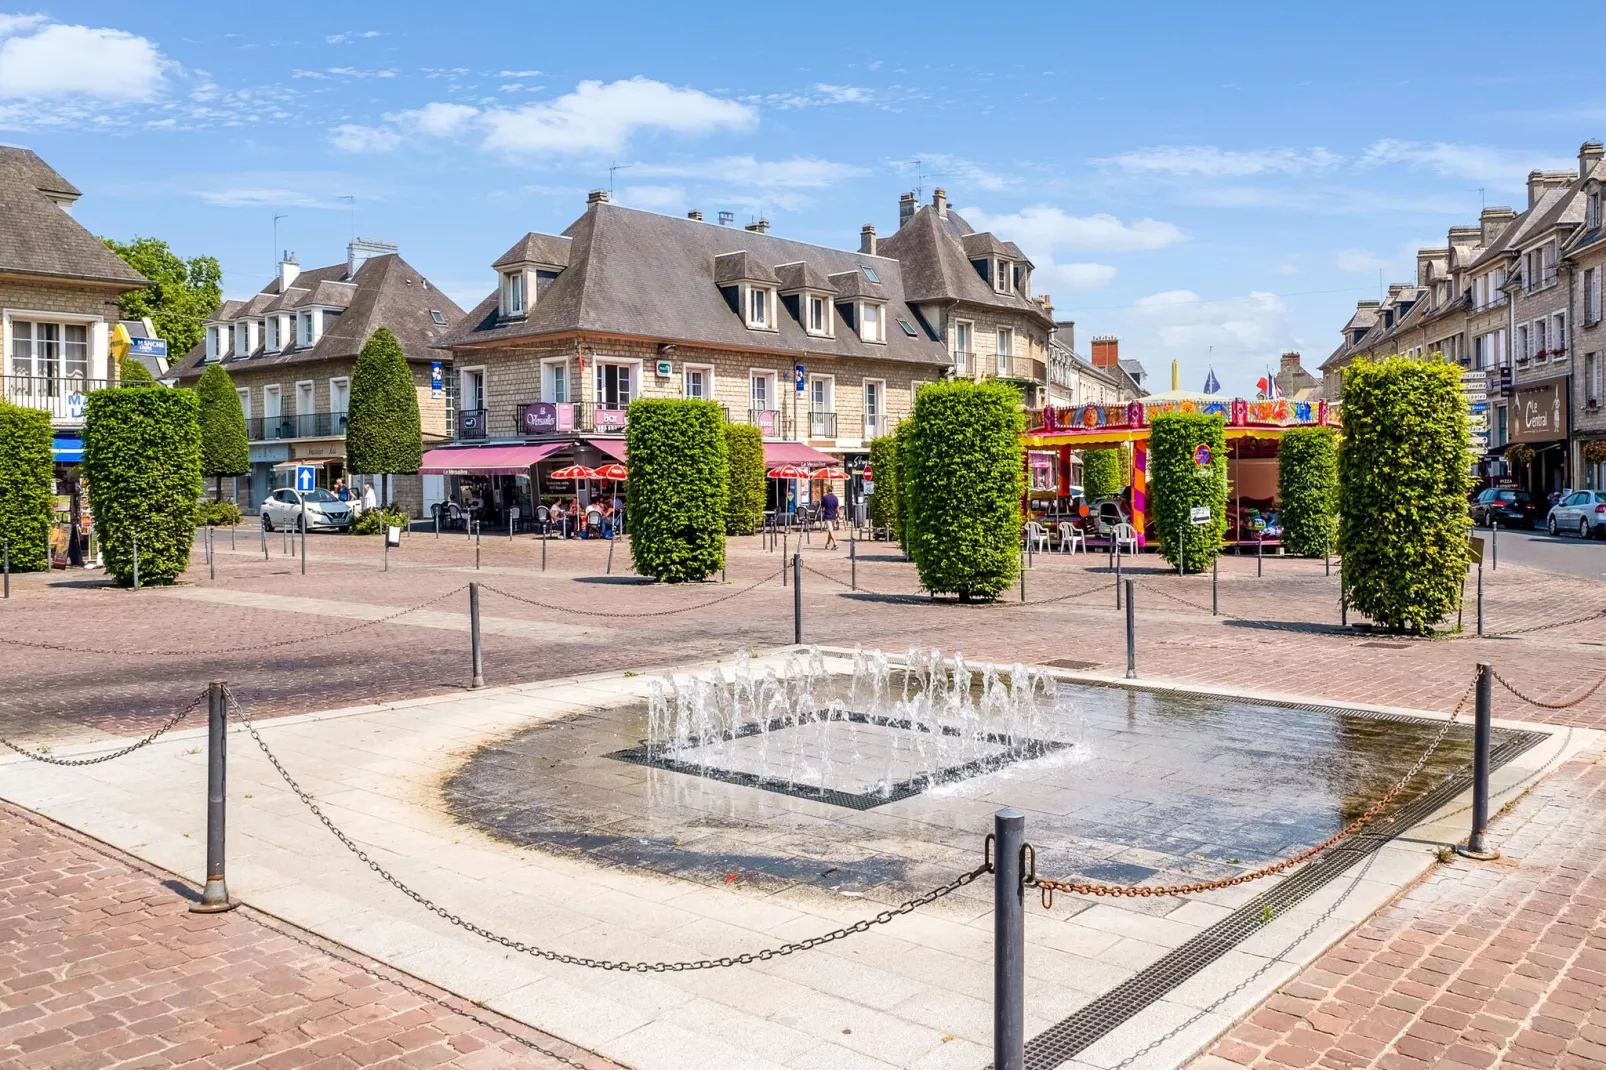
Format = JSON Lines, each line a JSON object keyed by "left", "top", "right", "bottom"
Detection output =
{"left": 905, "top": 379, "right": 1026, "bottom": 601}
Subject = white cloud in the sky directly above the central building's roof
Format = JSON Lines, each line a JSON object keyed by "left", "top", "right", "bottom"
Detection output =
{"left": 483, "top": 76, "right": 758, "bottom": 154}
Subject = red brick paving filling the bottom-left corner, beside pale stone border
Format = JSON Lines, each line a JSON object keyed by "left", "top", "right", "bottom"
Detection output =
{"left": 0, "top": 807, "right": 615, "bottom": 1070}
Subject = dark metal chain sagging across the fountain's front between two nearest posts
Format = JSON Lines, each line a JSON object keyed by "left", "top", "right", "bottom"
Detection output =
{"left": 225, "top": 692, "right": 993, "bottom": 974}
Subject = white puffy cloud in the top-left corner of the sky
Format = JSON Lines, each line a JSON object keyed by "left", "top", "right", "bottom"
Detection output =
{"left": 0, "top": 16, "right": 169, "bottom": 101}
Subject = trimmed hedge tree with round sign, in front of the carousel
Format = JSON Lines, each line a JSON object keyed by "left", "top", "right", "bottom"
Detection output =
{"left": 1148, "top": 413, "right": 1227, "bottom": 572}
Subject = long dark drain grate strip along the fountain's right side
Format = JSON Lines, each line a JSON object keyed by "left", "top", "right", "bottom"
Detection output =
{"left": 1026, "top": 715, "right": 1548, "bottom": 1070}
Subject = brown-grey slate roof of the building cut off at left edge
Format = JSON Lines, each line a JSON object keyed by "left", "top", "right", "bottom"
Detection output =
{"left": 0, "top": 146, "right": 149, "bottom": 289}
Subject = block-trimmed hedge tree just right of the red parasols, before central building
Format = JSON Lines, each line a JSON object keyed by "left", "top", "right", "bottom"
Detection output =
{"left": 625, "top": 398, "right": 731, "bottom": 583}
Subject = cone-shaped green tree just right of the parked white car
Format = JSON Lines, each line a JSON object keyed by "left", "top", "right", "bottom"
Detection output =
{"left": 345, "top": 328, "right": 423, "bottom": 507}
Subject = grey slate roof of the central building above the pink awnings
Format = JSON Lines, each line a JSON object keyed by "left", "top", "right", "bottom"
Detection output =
{"left": 437, "top": 201, "right": 951, "bottom": 366}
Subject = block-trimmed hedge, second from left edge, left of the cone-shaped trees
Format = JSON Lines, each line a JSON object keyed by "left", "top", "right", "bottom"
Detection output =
{"left": 84, "top": 387, "right": 204, "bottom": 585}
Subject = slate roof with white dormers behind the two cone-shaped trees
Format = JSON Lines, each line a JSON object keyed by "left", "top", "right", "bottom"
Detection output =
{"left": 177, "top": 252, "right": 463, "bottom": 381}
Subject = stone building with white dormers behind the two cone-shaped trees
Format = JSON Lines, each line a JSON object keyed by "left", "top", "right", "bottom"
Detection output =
{"left": 172, "top": 239, "right": 463, "bottom": 516}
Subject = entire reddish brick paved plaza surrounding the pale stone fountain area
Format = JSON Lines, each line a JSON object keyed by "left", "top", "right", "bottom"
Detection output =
{"left": 0, "top": 530, "right": 1606, "bottom": 1068}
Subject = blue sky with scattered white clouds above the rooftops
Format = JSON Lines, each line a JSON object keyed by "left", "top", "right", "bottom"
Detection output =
{"left": 0, "top": 2, "right": 1606, "bottom": 392}
